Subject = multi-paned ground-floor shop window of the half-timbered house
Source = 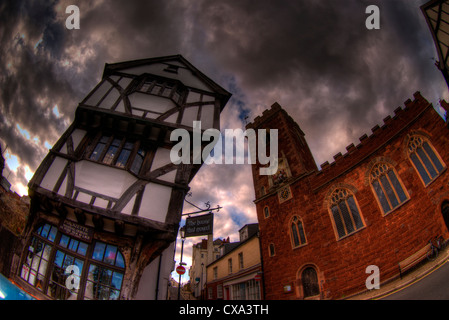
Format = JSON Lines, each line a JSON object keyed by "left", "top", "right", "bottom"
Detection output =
{"left": 20, "top": 223, "right": 125, "bottom": 300}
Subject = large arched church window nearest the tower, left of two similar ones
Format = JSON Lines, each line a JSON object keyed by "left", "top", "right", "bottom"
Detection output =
{"left": 329, "top": 188, "right": 364, "bottom": 238}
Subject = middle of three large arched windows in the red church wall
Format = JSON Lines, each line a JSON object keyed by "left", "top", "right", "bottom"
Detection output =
{"left": 370, "top": 162, "right": 408, "bottom": 214}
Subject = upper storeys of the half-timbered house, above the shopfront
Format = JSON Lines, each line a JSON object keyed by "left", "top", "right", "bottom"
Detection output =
{"left": 29, "top": 55, "right": 231, "bottom": 237}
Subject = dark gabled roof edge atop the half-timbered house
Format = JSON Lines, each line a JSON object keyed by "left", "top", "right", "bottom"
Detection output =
{"left": 103, "top": 54, "right": 231, "bottom": 110}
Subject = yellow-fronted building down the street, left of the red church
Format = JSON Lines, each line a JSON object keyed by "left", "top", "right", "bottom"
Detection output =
{"left": 206, "top": 223, "right": 263, "bottom": 300}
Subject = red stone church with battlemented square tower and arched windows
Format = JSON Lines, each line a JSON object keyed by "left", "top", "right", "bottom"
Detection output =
{"left": 247, "top": 92, "right": 449, "bottom": 300}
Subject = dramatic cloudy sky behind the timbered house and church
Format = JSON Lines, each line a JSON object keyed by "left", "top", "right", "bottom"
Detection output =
{"left": 0, "top": 0, "right": 448, "bottom": 280}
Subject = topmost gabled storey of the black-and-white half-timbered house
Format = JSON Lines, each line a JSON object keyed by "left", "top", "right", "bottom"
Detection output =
{"left": 80, "top": 55, "right": 231, "bottom": 130}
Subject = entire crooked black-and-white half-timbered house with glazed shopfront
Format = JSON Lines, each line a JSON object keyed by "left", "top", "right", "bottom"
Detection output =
{"left": 17, "top": 55, "right": 230, "bottom": 299}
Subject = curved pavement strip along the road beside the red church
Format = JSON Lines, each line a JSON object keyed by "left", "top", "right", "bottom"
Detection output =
{"left": 346, "top": 246, "right": 449, "bottom": 300}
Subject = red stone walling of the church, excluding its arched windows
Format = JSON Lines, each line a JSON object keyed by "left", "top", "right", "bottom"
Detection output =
{"left": 248, "top": 93, "right": 449, "bottom": 299}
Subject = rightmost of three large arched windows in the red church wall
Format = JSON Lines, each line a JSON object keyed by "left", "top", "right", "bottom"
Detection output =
{"left": 408, "top": 135, "right": 444, "bottom": 186}
